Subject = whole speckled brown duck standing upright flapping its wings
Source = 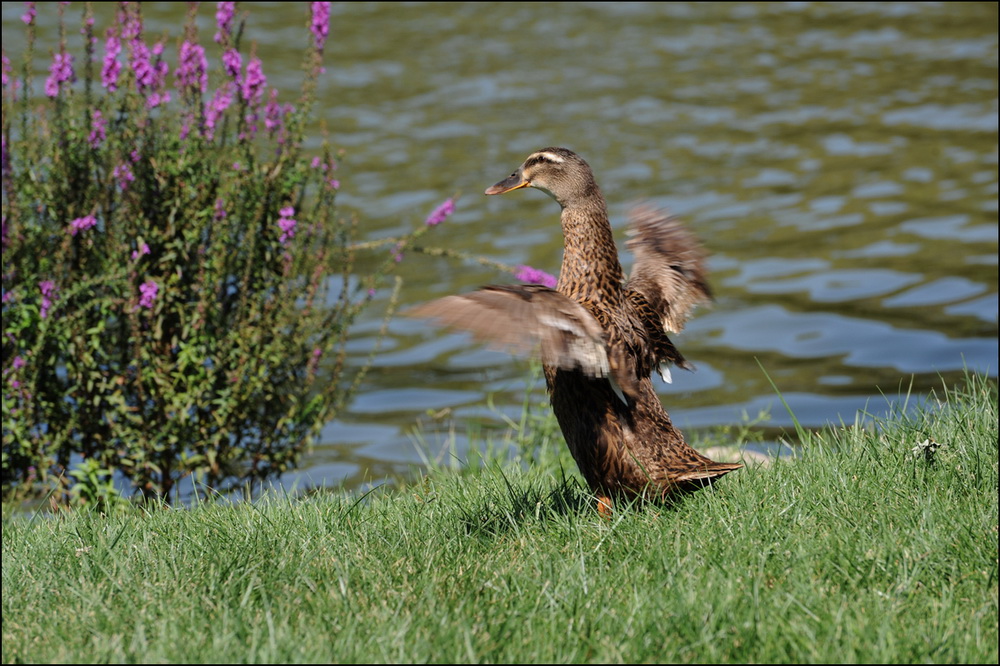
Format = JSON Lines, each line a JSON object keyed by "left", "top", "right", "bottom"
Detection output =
{"left": 414, "top": 148, "right": 742, "bottom": 513}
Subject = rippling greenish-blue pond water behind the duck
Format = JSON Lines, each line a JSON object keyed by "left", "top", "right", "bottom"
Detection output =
{"left": 3, "top": 2, "right": 998, "bottom": 487}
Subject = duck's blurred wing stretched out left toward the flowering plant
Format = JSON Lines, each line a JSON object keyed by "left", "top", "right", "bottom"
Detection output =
{"left": 406, "top": 285, "right": 610, "bottom": 377}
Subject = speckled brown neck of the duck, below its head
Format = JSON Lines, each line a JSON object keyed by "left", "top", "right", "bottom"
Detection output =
{"left": 556, "top": 187, "right": 624, "bottom": 304}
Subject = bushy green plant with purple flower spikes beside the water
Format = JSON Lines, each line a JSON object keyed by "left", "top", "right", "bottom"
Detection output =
{"left": 2, "top": 2, "right": 442, "bottom": 500}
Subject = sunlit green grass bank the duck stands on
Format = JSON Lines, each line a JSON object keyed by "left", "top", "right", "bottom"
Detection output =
{"left": 3, "top": 376, "right": 998, "bottom": 663}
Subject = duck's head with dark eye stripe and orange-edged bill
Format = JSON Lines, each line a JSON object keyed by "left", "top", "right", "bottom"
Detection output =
{"left": 486, "top": 148, "right": 598, "bottom": 207}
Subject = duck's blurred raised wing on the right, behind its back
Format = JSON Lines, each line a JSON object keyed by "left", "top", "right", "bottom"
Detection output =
{"left": 626, "top": 207, "right": 712, "bottom": 333}
